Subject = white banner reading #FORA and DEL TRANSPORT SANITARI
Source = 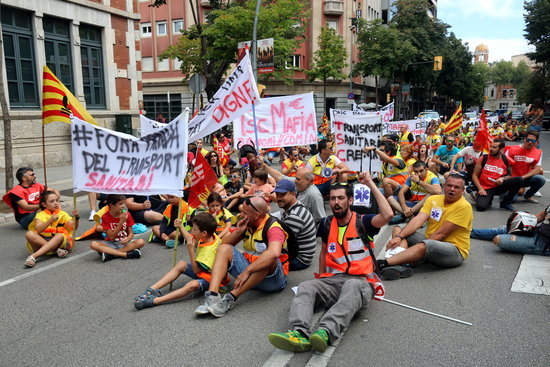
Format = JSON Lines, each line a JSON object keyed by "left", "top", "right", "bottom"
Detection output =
{"left": 71, "top": 113, "right": 188, "bottom": 196}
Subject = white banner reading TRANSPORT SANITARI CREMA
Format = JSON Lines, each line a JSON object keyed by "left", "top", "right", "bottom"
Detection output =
{"left": 331, "top": 110, "right": 382, "bottom": 172}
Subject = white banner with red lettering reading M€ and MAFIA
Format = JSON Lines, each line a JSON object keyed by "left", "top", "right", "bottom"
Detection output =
{"left": 233, "top": 92, "right": 317, "bottom": 148}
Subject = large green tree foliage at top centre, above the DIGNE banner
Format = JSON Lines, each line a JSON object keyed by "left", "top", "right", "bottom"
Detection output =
{"left": 159, "top": 0, "right": 309, "bottom": 98}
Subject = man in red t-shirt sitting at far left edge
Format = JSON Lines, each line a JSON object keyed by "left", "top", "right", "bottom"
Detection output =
{"left": 2, "top": 167, "right": 61, "bottom": 229}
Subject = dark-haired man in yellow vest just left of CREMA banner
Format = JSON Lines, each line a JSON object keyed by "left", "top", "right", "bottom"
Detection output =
{"left": 306, "top": 139, "right": 349, "bottom": 195}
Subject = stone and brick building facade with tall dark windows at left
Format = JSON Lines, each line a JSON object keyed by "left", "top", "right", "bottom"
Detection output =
{"left": 0, "top": 0, "right": 142, "bottom": 170}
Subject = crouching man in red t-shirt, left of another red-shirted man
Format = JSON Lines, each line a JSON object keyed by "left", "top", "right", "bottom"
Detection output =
{"left": 472, "top": 139, "right": 523, "bottom": 212}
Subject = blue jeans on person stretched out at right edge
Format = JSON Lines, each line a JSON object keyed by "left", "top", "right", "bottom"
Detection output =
{"left": 470, "top": 225, "right": 550, "bottom": 256}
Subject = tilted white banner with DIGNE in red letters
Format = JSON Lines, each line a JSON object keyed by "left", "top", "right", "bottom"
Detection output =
{"left": 189, "top": 51, "right": 260, "bottom": 141}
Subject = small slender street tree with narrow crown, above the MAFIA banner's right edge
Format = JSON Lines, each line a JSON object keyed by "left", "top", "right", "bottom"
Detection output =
{"left": 305, "top": 27, "right": 347, "bottom": 111}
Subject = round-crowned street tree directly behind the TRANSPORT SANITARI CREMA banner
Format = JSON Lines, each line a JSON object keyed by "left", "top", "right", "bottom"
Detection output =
{"left": 353, "top": 19, "right": 416, "bottom": 104}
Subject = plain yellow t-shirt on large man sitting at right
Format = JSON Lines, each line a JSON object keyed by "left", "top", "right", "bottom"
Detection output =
{"left": 421, "top": 195, "right": 474, "bottom": 259}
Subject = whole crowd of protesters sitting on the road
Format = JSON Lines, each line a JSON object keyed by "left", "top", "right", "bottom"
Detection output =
{"left": 4, "top": 108, "right": 550, "bottom": 351}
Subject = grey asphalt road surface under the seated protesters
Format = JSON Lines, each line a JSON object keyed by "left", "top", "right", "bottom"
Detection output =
{"left": 0, "top": 132, "right": 550, "bottom": 367}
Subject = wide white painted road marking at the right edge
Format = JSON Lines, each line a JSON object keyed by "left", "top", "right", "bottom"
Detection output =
{"left": 510, "top": 255, "right": 550, "bottom": 296}
